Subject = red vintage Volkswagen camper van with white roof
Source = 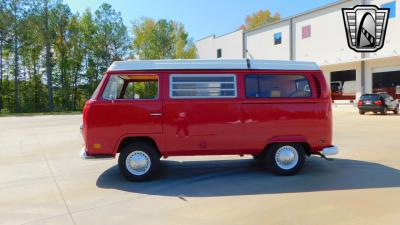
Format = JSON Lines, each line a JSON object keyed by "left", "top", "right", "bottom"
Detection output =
{"left": 81, "top": 60, "right": 338, "bottom": 181}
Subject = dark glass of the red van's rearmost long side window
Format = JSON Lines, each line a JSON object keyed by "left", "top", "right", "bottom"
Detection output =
{"left": 245, "top": 75, "right": 311, "bottom": 98}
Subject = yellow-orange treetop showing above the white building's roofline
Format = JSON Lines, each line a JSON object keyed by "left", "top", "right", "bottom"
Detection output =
{"left": 240, "top": 9, "right": 281, "bottom": 30}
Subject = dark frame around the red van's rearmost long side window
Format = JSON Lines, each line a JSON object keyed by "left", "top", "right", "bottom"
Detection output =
{"left": 243, "top": 73, "right": 314, "bottom": 100}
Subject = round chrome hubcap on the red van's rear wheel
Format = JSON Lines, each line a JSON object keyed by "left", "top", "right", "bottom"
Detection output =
{"left": 275, "top": 145, "right": 299, "bottom": 170}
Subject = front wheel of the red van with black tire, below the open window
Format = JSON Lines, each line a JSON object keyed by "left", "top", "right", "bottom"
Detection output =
{"left": 118, "top": 142, "right": 160, "bottom": 181}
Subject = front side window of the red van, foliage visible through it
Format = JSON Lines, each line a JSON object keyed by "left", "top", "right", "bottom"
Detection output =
{"left": 102, "top": 75, "right": 158, "bottom": 100}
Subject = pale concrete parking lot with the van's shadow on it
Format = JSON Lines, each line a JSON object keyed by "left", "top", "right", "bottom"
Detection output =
{"left": 0, "top": 107, "right": 400, "bottom": 225}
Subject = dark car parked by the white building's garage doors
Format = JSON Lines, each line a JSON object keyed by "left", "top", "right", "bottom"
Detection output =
{"left": 358, "top": 92, "right": 399, "bottom": 115}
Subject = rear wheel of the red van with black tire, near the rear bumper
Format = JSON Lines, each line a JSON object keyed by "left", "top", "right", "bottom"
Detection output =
{"left": 266, "top": 143, "right": 306, "bottom": 176}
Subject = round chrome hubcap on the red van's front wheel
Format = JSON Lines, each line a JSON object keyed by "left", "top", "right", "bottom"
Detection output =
{"left": 125, "top": 150, "right": 151, "bottom": 176}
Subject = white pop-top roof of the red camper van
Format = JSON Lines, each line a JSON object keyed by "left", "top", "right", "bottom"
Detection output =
{"left": 108, "top": 59, "right": 320, "bottom": 71}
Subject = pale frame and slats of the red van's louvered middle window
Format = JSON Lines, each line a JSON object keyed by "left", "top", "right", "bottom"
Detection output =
{"left": 168, "top": 73, "right": 238, "bottom": 99}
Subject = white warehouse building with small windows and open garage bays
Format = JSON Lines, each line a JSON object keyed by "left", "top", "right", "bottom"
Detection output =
{"left": 196, "top": 0, "right": 400, "bottom": 98}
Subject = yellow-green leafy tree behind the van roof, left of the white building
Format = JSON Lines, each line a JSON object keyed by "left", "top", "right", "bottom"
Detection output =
{"left": 131, "top": 18, "right": 196, "bottom": 59}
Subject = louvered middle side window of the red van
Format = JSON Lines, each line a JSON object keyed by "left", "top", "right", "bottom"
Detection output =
{"left": 170, "top": 74, "right": 237, "bottom": 98}
